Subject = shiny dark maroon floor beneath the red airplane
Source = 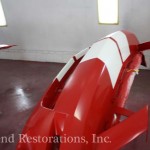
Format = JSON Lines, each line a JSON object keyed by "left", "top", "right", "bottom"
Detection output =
{"left": 0, "top": 60, "right": 150, "bottom": 150}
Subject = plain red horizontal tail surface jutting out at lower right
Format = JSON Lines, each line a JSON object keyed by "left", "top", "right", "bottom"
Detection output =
{"left": 96, "top": 106, "right": 148, "bottom": 150}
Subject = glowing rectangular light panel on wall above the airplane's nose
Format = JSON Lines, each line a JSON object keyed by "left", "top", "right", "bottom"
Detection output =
{"left": 98, "top": 0, "right": 119, "bottom": 24}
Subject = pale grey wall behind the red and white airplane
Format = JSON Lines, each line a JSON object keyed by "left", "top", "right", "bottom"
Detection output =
{"left": 0, "top": 0, "right": 150, "bottom": 66}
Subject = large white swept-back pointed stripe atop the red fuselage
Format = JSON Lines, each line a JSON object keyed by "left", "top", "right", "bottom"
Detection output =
{"left": 81, "top": 38, "right": 122, "bottom": 88}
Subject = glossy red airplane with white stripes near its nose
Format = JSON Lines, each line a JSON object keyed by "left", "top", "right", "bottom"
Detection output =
{"left": 17, "top": 31, "right": 150, "bottom": 150}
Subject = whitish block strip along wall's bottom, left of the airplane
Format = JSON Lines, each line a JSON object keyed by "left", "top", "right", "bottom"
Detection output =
{"left": 0, "top": 49, "right": 77, "bottom": 63}
